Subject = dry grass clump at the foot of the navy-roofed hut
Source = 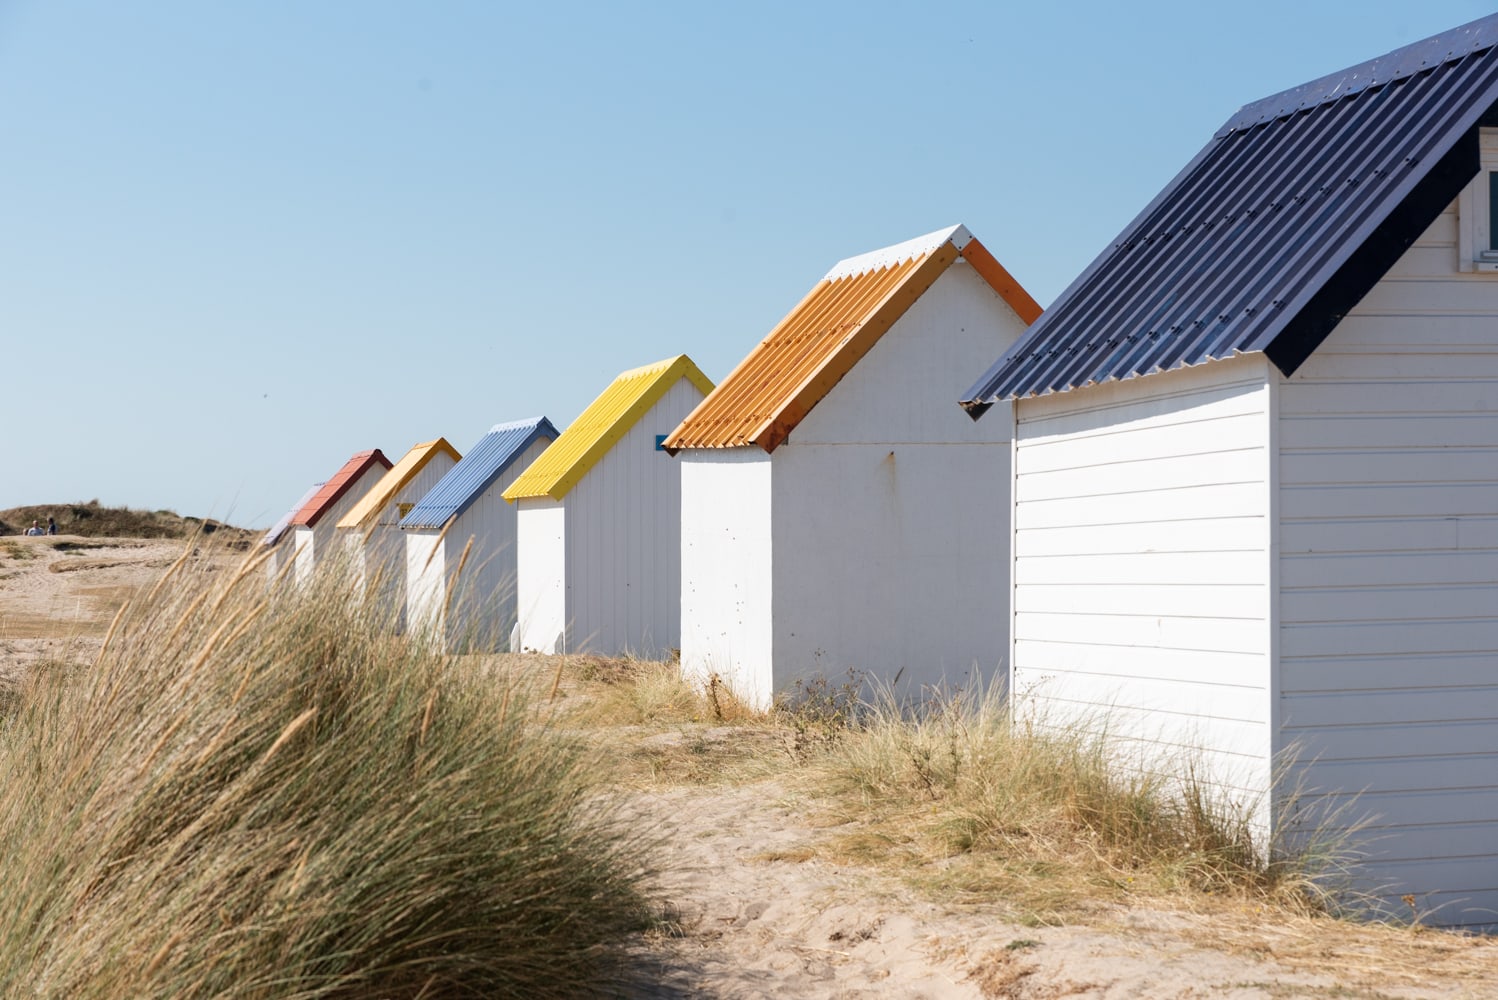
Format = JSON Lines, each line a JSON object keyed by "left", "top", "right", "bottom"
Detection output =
{"left": 810, "top": 689, "right": 1348, "bottom": 922}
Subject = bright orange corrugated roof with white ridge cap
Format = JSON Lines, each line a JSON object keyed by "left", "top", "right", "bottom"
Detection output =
{"left": 665, "top": 226, "right": 1040, "bottom": 454}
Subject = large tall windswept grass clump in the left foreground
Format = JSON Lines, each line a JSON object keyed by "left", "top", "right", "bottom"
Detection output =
{"left": 0, "top": 547, "right": 649, "bottom": 999}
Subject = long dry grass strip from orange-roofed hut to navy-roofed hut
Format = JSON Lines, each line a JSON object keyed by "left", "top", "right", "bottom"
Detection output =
{"left": 568, "top": 657, "right": 1369, "bottom": 924}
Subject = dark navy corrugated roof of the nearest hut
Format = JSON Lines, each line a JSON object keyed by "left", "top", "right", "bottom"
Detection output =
{"left": 963, "top": 15, "right": 1498, "bottom": 415}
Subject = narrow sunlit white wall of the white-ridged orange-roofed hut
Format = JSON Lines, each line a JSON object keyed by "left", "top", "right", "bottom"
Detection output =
{"left": 677, "top": 448, "right": 774, "bottom": 705}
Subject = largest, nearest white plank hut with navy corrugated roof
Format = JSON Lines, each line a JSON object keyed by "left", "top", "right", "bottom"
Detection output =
{"left": 965, "top": 16, "right": 1498, "bottom": 925}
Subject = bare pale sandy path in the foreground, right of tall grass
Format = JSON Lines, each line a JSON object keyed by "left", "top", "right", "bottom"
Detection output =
{"left": 635, "top": 780, "right": 1498, "bottom": 1000}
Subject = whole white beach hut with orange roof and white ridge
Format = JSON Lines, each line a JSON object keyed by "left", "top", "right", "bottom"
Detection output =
{"left": 665, "top": 226, "right": 1040, "bottom": 707}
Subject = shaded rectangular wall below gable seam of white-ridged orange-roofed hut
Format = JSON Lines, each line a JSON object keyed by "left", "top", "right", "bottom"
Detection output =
{"left": 771, "top": 440, "right": 1010, "bottom": 695}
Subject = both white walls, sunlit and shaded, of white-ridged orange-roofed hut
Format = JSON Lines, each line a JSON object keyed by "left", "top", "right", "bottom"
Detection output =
{"left": 680, "top": 262, "right": 1025, "bottom": 707}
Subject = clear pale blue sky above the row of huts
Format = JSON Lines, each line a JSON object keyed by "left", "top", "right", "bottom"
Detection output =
{"left": 0, "top": 0, "right": 1491, "bottom": 527}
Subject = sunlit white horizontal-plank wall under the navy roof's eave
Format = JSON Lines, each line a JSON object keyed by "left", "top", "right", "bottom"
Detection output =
{"left": 1006, "top": 358, "right": 1273, "bottom": 801}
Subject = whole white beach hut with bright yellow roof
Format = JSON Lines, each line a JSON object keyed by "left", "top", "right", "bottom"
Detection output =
{"left": 505, "top": 355, "right": 713, "bottom": 657}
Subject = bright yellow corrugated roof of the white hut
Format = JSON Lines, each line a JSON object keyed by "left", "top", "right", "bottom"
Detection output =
{"left": 505, "top": 355, "right": 713, "bottom": 500}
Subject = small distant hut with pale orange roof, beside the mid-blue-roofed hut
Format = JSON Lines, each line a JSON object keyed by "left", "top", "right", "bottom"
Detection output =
{"left": 339, "top": 437, "right": 461, "bottom": 617}
